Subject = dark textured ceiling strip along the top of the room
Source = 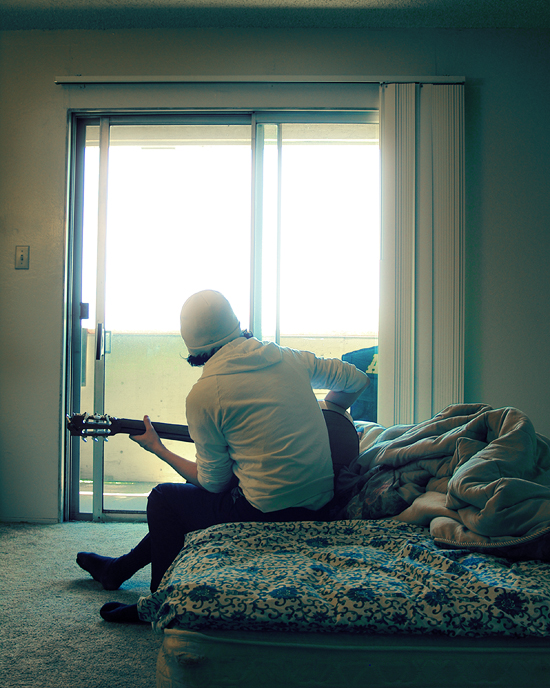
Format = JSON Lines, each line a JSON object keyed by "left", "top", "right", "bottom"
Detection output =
{"left": 0, "top": 0, "right": 550, "bottom": 30}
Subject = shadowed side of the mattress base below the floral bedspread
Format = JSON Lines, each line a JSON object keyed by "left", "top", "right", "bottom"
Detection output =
{"left": 157, "top": 629, "right": 550, "bottom": 688}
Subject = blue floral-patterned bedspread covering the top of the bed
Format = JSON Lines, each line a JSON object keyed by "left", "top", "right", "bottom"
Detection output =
{"left": 138, "top": 519, "right": 550, "bottom": 636}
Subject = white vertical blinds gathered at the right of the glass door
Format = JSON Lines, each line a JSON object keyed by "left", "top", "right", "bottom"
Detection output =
{"left": 378, "top": 83, "right": 464, "bottom": 426}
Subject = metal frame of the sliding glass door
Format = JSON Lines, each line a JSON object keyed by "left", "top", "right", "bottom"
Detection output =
{"left": 64, "top": 107, "right": 379, "bottom": 521}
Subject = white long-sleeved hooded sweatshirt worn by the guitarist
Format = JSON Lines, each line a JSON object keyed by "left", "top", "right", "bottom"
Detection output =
{"left": 187, "top": 337, "right": 366, "bottom": 512}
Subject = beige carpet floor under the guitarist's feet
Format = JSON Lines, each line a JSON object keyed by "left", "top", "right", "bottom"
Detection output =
{"left": 0, "top": 522, "right": 161, "bottom": 688}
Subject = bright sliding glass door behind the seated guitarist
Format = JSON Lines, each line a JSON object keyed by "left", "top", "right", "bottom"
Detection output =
{"left": 68, "top": 112, "right": 379, "bottom": 520}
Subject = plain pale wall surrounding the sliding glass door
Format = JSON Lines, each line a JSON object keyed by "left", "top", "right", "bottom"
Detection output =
{"left": 0, "top": 29, "right": 550, "bottom": 522}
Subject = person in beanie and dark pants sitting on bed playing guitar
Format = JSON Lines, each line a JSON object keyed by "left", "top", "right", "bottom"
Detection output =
{"left": 77, "top": 290, "right": 370, "bottom": 621}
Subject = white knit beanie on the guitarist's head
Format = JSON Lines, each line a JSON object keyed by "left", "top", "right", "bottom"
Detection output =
{"left": 180, "top": 289, "right": 241, "bottom": 356}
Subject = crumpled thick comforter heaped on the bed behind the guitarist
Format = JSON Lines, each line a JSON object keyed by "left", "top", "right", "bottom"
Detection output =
{"left": 333, "top": 404, "right": 550, "bottom": 560}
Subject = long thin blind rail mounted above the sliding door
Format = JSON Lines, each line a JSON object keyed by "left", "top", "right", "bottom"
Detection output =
{"left": 55, "top": 74, "right": 466, "bottom": 85}
